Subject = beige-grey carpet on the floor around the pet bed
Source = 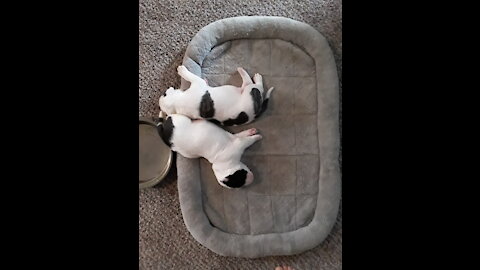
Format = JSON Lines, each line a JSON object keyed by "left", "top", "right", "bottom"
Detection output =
{"left": 139, "top": 0, "right": 342, "bottom": 270}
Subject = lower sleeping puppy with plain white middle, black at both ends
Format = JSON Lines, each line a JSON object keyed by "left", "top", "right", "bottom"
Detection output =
{"left": 158, "top": 114, "right": 262, "bottom": 188}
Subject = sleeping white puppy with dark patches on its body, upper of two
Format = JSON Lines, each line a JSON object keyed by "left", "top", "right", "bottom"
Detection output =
{"left": 159, "top": 66, "right": 273, "bottom": 126}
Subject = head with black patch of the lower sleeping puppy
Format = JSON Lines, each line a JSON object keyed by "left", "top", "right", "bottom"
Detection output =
{"left": 212, "top": 163, "right": 253, "bottom": 188}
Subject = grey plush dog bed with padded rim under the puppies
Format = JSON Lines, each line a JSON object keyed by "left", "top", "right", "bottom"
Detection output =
{"left": 177, "top": 16, "right": 341, "bottom": 258}
